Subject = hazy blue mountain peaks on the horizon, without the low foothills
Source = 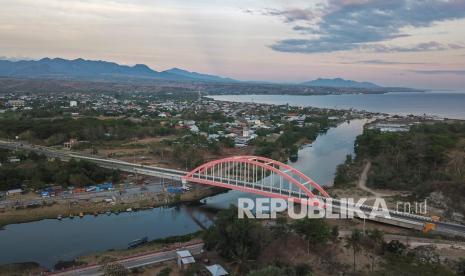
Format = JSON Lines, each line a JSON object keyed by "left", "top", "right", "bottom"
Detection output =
{"left": 0, "top": 58, "right": 380, "bottom": 89}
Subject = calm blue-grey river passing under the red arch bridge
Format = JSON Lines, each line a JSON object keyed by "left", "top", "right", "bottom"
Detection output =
{"left": 0, "top": 117, "right": 365, "bottom": 268}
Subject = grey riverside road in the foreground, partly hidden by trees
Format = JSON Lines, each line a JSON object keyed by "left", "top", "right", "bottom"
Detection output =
{"left": 49, "top": 243, "right": 203, "bottom": 276}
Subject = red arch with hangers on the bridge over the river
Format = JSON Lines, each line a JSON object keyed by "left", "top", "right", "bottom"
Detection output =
{"left": 181, "top": 156, "right": 329, "bottom": 204}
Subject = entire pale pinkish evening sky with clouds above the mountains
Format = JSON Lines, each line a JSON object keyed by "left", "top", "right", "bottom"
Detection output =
{"left": 0, "top": 0, "right": 465, "bottom": 91}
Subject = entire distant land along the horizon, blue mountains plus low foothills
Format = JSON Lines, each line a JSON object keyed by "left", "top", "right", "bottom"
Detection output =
{"left": 0, "top": 58, "right": 421, "bottom": 95}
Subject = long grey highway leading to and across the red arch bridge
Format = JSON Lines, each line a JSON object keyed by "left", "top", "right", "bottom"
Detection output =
{"left": 0, "top": 140, "right": 465, "bottom": 236}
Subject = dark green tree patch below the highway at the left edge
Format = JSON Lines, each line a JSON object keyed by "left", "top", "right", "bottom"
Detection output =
{"left": 0, "top": 150, "right": 119, "bottom": 191}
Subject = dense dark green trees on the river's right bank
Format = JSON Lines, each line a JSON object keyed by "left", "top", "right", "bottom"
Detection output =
{"left": 335, "top": 122, "right": 465, "bottom": 211}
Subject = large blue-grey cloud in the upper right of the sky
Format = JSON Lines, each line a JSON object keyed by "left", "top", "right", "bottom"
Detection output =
{"left": 265, "top": 0, "right": 465, "bottom": 53}
